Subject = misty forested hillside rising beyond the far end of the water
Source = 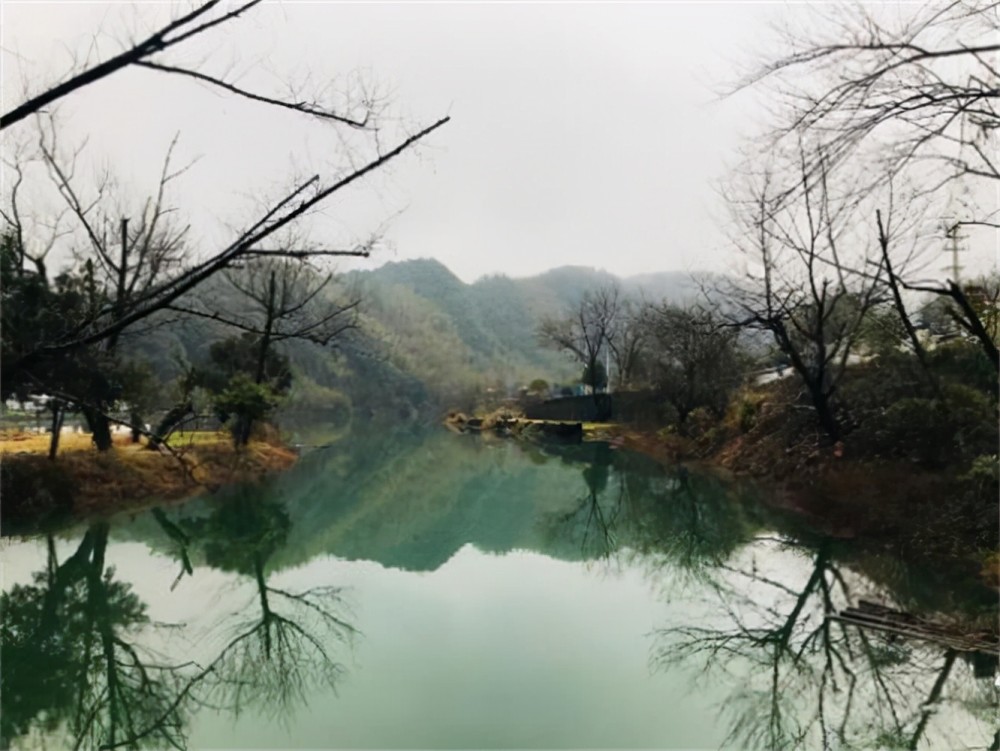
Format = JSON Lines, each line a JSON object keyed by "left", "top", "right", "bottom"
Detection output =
{"left": 103, "top": 259, "right": 695, "bottom": 425}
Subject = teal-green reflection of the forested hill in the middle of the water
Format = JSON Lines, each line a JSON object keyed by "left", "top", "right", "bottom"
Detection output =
{"left": 286, "top": 435, "right": 582, "bottom": 570}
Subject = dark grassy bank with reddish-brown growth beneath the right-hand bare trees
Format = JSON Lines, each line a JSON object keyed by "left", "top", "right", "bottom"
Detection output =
{"left": 452, "top": 382, "right": 1000, "bottom": 587}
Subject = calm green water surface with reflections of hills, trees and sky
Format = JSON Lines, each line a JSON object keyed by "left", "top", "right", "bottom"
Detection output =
{"left": 0, "top": 431, "right": 997, "bottom": 749}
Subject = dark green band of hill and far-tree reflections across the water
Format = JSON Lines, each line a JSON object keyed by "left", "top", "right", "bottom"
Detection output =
{"left": 132, "top": 431, "right": 749, "bottom": 571}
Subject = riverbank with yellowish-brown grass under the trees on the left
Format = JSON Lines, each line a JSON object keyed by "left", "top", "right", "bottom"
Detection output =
{"left": 0, "top": 432, "right": 297, "bottom": 534}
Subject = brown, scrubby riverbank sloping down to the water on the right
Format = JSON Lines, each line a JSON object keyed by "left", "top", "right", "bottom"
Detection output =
{"left": 448, "top": 394, "right": 1000, "bottom": 589}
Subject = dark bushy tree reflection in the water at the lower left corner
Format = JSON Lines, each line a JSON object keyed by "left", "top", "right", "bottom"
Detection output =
{"left": 0, "top": 523, "right": 189, "bottom": 749}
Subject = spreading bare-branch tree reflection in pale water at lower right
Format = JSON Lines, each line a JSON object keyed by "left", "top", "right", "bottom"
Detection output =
{"left": 653, "top": 543, "right": 997, "bottom": 749}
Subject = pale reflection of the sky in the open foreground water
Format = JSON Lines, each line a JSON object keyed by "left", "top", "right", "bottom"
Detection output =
{"left": 192, "top": 547, "right": 723, "bottom": 748}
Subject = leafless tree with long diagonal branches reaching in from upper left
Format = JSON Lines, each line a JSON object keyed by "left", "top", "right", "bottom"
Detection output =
{"left": 0, "top": 0, "right": 449, "bottom": 448}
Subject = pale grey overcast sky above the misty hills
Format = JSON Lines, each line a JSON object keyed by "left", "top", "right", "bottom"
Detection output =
{"left": 2, "top": 0, "right": 920, "bottom": 280}
